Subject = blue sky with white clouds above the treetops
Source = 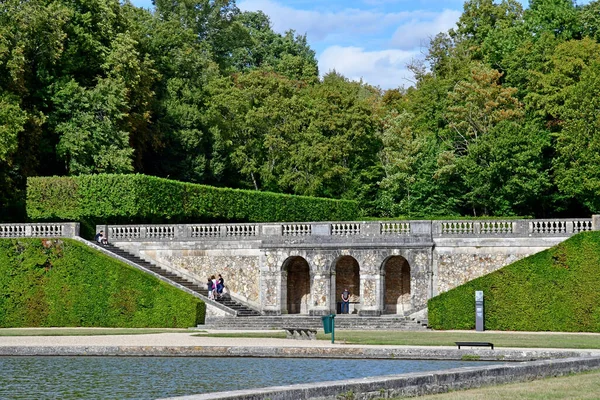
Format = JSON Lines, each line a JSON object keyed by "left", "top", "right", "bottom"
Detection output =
{"left": 131, "top": 0, "right": 589, "bottom": 89}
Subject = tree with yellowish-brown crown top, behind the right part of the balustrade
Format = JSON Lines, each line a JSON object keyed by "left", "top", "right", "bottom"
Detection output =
{"left": 437, "top": 64, "right": 550, "bottom": 215}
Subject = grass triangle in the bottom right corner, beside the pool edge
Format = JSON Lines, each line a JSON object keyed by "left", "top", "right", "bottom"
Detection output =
{"left": 408, "top": 371, "right": 600, "bottom": 400}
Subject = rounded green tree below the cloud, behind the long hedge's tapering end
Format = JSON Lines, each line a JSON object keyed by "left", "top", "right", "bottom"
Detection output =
{"left": 279, "top": 72, "right": 381, "bottom": 200}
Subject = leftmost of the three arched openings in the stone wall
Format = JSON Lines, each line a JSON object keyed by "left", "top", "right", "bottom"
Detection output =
{"left": 284, "top": 257, "right": 310, "bottom": 314}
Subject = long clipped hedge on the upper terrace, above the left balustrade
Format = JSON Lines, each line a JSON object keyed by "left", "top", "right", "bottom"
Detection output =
{"left": 27, "top": 174, "right": 359, "bottom": 227}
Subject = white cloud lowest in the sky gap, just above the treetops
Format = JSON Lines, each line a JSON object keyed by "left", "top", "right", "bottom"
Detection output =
{"left": 319, "top": 46, "right": 418, "bottom": 89}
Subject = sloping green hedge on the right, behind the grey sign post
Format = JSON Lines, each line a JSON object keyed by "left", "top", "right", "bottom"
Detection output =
{"left": 429, "top": 232, "right": 600, "bottom": 332}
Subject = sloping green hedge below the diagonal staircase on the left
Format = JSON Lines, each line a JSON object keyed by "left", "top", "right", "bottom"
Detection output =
{"left": 0, "top": 239, "right": 206, "bottom": 328}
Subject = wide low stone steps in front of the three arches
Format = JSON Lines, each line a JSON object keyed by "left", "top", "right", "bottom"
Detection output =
{"left": 203, "top": 314, "right": 428, "bottom": 330}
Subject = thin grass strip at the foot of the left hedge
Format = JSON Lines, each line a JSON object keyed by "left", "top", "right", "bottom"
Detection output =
{"left": 0, "top": 328, "right": 190, "bottom": 336}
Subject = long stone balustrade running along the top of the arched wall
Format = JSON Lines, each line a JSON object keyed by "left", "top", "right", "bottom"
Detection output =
{"left": 99, "top": 216, "right": 600, "bottom": 241}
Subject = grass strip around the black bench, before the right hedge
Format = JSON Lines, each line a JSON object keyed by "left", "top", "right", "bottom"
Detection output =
{"left": 195, "top": 331, "right": 600, "bottom": 349}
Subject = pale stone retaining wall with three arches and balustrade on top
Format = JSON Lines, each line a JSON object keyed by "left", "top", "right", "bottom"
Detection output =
{"left": 96, "top": 215, "right": 600, "bottom": 316}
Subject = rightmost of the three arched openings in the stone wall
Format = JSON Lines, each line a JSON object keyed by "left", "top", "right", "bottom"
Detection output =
{"left": 383, "top": 256, "right": 411, "bottom": 314}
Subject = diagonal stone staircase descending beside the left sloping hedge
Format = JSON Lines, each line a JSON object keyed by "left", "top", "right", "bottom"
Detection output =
{"left": 103, "top": 244, "right": 260, "bottom": 321}
